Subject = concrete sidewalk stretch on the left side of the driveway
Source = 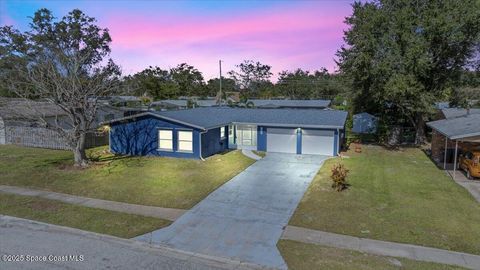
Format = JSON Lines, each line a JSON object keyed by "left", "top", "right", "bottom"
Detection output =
{"left": 0, "top": 185, "right": 187, "bottom": 221}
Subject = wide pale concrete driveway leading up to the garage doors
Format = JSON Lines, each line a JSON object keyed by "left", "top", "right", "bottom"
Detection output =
{"left": 137, "top": 153, "right": 327, "bottom": 269}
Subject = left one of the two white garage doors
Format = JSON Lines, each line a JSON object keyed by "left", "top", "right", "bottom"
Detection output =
{"left": 267, "top": 128, "right": 297, "bottom": 154}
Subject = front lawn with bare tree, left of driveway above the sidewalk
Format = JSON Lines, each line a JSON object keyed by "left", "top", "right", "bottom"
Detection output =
{"left": 0, "top": 145, "right": 254, "bottom": 209}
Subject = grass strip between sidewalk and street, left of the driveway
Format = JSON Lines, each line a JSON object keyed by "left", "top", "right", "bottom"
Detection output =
{"left": 0, "top": 193, "right": 170, "bottom": 238}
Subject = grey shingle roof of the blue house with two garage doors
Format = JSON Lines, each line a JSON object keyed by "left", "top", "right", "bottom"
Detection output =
{"left": 105, "top": 107, "right": 347, "bottom": 130}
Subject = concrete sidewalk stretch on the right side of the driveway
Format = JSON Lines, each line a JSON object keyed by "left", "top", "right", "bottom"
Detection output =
{"left": 282, "top": 226, "right": 480, "bottom": 269}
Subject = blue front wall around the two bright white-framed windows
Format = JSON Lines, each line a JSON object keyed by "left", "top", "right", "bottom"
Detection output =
{"left": 110, "top": 116, "right": 200, "bottom": 158}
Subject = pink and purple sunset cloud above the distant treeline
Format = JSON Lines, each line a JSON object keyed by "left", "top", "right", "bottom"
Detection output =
{"left": 105, "top": 2, "right": 350, "bottom": 79}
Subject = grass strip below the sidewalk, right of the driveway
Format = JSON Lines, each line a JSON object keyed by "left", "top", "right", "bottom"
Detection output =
{"left": 278, "top": 240, "right": 463, "bottom": 270}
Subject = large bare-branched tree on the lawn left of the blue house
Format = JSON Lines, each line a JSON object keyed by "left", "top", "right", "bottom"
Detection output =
{"left": 0, "top": 9, "right": 120, "bottom": 167}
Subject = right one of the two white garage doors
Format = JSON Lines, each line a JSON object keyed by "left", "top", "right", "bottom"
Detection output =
{"left": 302, "top": 129, "right": 335, "bottom": 156}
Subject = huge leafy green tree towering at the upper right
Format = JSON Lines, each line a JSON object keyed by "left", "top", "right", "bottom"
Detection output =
{"left": 337, "top": 0, "right": 480, "bottom": 143}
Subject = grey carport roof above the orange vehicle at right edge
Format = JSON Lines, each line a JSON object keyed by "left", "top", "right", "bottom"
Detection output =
{"left": 427, "top": 114, "right": 480, "bottom": 139}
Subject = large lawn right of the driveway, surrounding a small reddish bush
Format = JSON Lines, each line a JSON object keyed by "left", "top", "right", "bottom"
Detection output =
{"left": 290, "top": 145, "right": 480, "bottom": 254}
